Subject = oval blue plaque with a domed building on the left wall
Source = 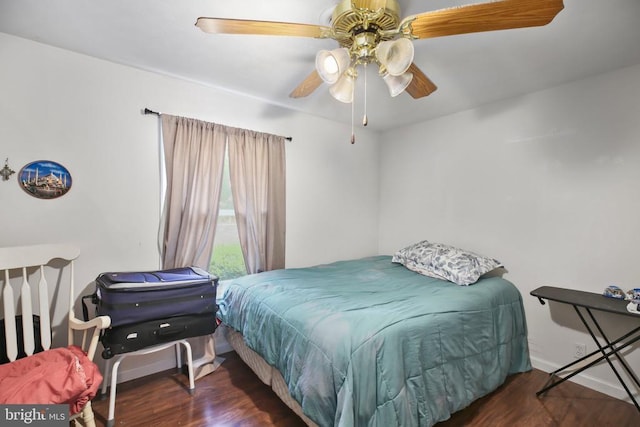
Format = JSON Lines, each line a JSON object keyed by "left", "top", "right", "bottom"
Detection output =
{"left": 18, "top": 160, "right": 73, "bottom": 199}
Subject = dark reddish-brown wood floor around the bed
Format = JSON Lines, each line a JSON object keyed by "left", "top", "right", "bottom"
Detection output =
{"left": 93, "top": 352, "right": 640, "bottom": 427}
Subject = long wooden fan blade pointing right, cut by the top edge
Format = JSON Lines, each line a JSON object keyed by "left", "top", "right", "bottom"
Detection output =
{"left": 408, "top": 0, "right": 564, "bottom": 38}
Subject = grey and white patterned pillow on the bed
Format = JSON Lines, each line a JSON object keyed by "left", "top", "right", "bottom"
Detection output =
{"left": 391, "top": 240, "right": 503, "bottom": 286}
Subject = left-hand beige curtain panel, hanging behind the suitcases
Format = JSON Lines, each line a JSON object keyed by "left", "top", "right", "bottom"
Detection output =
{"left": 160, "top": 114, "right": 226, "bottom": 378}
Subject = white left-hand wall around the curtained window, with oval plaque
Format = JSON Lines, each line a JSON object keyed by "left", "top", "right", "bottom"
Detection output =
{"left": 0, "top": 33, "right": 378, "bottom": 378}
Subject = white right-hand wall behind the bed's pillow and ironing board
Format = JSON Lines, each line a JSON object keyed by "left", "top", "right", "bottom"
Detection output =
{"left": 380, "top": 65, "right": 640, "bottom": 397}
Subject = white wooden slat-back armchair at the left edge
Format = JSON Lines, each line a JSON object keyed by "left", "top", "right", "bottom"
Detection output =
{"left": 0, "top": 244, "right": 111, "bottom": 426}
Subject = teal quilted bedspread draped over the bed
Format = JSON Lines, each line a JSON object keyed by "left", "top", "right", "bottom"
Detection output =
{"left": 219, "top": 256, "right": 531, "bottom": 427}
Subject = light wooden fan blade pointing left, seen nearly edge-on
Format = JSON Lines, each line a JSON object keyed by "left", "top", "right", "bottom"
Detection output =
{"left": 196, "top": 17, "right": 331, "bottom": 38}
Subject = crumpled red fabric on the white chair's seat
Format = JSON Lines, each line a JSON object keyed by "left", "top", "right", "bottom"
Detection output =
{"left": 0, "top": 346, "right": 102, "bottom": 414}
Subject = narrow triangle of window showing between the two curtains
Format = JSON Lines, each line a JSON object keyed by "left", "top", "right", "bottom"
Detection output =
{"left": 209, "top": 151, "right": 247, "bottom": 280}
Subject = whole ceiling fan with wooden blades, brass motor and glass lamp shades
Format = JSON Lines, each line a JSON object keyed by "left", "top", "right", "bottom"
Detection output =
{"left": 196, "top": 0, "right": 564, "bottom": 103}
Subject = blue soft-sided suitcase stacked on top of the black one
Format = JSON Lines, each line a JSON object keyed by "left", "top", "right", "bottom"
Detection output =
{"left": 90, "top": 267, "right": 218, "bottom": 327}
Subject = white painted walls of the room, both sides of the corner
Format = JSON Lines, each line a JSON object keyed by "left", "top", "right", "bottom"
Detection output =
{"left": 0, "top": 29, "right": 640, "bottom": 397}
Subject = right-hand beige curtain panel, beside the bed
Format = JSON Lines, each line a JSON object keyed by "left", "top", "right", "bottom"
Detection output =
{"left": 228, "top": 129, "right": 286, "bottom": 274}
